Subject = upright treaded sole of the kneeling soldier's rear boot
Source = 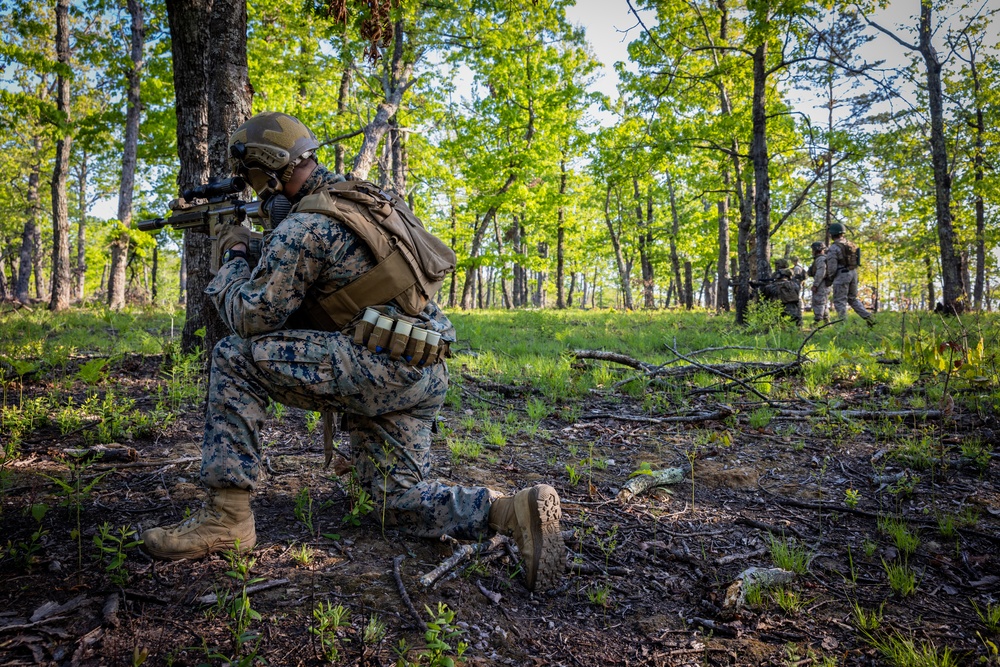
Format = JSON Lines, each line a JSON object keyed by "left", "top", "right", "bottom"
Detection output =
{"left": 515, "top": 487, "right": 566, "bottom": 591}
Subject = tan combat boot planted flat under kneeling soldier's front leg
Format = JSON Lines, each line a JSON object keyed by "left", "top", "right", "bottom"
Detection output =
{"left": 142, "top": 489, "right": 257, "bottom": 560}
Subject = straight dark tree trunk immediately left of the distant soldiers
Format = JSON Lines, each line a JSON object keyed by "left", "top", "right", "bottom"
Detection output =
{"left": 750, "top": 42, "right": 771, "bottom": 280}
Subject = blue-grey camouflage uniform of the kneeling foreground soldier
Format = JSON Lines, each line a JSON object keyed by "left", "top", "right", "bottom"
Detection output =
{"left": 201, "top": 166, "right": 500, "bottom": 538}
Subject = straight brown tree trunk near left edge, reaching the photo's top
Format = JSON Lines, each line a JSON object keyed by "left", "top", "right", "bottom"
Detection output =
{"left": 49, "top": 0, "right": 73, "bottom": 311}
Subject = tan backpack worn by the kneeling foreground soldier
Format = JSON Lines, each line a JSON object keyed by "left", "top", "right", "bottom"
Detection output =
{"left": 292, "top": 180, "right": 455, "bottom": 331}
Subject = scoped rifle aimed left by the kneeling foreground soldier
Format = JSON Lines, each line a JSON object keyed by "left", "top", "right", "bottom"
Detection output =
{"left": 136, "top": 176, "right": 291, "bottom": 275}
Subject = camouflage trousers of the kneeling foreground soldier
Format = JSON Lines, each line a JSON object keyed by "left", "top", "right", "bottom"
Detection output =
{"left": 201, "top": 330, "right": 500, "bottom": 538}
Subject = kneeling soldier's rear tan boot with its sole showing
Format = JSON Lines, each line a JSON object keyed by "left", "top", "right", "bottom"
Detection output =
{"left": 489, "top": 484, "right": 566, "bottom": 591}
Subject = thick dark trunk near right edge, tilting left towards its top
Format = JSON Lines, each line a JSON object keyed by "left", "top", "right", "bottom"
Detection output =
{"left": 920, "top": 0, "right": 966, "bottom": 313}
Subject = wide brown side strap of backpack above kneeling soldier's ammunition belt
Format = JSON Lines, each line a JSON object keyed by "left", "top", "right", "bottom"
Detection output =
{"left": 302, "top": 247, "right": 417, "bottom": 331}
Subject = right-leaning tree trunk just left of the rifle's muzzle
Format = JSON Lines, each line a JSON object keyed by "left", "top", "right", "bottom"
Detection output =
{"left": 108, "top": 0, "right": 146, "bottom": 310}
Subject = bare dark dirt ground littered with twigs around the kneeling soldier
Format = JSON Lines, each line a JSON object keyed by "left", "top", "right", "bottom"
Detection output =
{"left": 0, "top": 358, "right": 1000, "bottom": 667}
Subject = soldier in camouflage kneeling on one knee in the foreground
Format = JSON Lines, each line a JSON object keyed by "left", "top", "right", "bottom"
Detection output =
{"left": 142, "top": 112, "right": 565, "bottom": 590}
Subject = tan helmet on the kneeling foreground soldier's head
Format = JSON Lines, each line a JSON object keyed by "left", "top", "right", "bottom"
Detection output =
{"left": 229, "top": 111, "right": 319, "bottom": 194}
